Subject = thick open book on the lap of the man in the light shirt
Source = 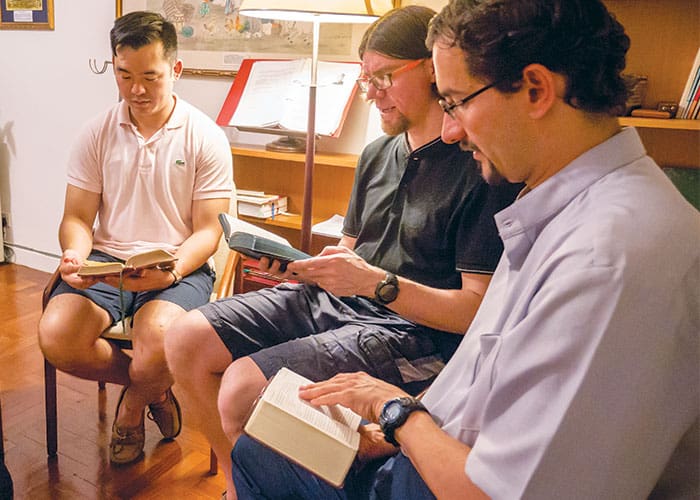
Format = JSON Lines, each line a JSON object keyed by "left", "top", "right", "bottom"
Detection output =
{"left": 243, "top": 368, "right": 361, "bottom": 487}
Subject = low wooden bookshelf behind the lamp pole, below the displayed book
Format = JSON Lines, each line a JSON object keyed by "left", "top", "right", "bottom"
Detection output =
{"left": 231, "top": 144, "right": 358, "bottom": 253}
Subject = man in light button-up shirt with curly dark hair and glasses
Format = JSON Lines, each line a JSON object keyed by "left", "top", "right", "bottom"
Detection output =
{"left": 227, "top": 0, "right": 700, "bottom": 499}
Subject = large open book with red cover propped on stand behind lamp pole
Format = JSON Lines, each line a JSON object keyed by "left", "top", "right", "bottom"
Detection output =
{"left": 216, "top": 59, "right": 362, "bottom": 137}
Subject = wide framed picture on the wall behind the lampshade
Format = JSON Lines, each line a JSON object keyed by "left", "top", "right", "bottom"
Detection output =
{"left": 115, "top": 0, "right": 367, "bottom": 77}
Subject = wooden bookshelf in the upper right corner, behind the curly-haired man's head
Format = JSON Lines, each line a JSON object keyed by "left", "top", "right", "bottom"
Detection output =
{"left": 605, "top": 0, "right": 700, "bottom": 168}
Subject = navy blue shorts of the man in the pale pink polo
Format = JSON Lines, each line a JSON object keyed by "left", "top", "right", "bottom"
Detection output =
{"left": 51, "top": 250, "right": 216, "bottom": 324}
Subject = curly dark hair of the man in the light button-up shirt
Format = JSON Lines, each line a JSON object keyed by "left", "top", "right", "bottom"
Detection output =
{"left": 426, "top": 0, "right": 630, "bottom": 115}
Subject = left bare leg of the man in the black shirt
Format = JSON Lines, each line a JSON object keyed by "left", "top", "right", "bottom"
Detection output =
{"left": 165, "top": 309, "right": 235, "bottom": 500}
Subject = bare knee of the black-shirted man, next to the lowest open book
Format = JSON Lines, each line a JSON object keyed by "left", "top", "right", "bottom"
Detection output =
{"left": 218, "top": 357, "right": 267, "bottom": 442}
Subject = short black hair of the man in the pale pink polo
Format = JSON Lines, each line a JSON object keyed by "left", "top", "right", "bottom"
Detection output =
{"left": 109, "top": 11, "right": 177, "bottom": 62}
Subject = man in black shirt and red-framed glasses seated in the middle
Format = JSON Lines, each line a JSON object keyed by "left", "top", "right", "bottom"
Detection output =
{"left": 166, "top": 6, "right": 518, "bottom": 498}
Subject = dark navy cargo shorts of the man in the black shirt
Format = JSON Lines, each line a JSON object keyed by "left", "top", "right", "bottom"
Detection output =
{"left": 199, "top": 283, "right": 462, "bottom": 394}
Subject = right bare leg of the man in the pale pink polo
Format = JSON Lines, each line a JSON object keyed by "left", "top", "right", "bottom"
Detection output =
{"left": 116, "top": 300, "right": 185, "bottom": 427}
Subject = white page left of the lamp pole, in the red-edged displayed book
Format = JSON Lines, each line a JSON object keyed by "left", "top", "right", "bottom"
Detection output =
{"left": 229, "top": 59, "right": 304, "bottom": 127}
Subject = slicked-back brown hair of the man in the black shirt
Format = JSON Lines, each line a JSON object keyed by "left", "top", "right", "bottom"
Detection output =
{"left": 358, "top": 5, "right": 435, "bottom": 59}
